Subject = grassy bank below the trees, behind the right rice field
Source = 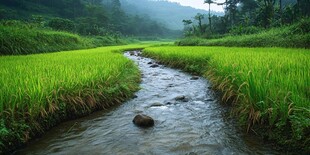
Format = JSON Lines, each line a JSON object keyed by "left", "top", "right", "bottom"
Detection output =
{"left": 176, "top": 19, "right": 310, "bottom": 48}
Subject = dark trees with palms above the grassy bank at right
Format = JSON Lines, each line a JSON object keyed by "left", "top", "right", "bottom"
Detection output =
{"left": 183, "top": 0, "right": 310, "bottom": 38}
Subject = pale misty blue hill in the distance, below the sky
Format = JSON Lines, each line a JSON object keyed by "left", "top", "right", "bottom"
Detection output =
{"left": 121, "top": 0, "right": 224, "bottom": 30}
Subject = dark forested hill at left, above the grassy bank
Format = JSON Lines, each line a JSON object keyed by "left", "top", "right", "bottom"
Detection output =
{"left": 0, "top": 0, "right": 176, "bottom": 37}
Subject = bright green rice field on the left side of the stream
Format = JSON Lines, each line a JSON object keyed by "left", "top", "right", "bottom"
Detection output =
{"left": 0, "top": 44, "right": 153, "bottom": 154}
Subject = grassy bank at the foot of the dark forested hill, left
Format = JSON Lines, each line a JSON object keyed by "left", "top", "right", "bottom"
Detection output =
{"left": 0, "top": 21, "right": 132, "bottom": 55}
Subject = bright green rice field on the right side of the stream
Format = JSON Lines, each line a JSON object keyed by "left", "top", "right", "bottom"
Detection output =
{"left": 144, "top": 46, "right": 310, "bottom": 153}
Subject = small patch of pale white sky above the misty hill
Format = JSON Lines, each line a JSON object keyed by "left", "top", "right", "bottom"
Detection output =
{"left": 168, "top": 0, "right": 225, "bottom": 12}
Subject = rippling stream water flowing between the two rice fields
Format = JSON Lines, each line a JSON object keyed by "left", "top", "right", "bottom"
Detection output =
{"left": 15, "top": 53, "right": 280, "bottom": 155}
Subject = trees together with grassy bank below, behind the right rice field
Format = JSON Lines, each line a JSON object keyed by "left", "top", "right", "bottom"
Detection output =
{"left": 178, "top": 0, "right": 310, "bottom": 48}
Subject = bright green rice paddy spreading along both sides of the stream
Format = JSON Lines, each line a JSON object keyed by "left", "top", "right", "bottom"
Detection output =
{"left": 0, "top": 43, "right": 310, "bottom": 153}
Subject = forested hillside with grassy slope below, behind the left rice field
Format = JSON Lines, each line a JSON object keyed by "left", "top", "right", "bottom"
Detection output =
{"left": 0, "top": 0, "right": 180, "bottom": 55}
